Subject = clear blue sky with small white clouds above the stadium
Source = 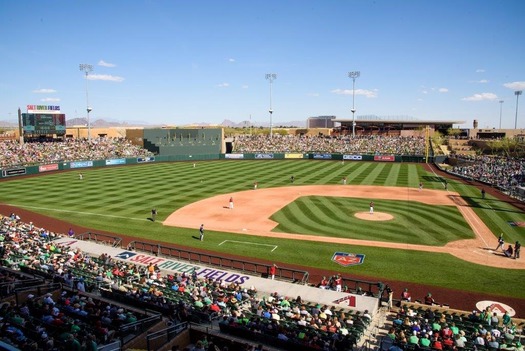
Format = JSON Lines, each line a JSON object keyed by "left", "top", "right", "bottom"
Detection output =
{"left": 0, "top": 0, "right": 525, "bottom": 128}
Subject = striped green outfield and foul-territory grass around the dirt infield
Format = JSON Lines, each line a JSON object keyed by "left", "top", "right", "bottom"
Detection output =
{"left": 0, "top": 160, "right": 525, "bottom": 298}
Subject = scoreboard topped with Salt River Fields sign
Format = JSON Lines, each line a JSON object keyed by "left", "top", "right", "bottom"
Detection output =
{"left": 22, "top": 105, "right": 66, "bottom": 136}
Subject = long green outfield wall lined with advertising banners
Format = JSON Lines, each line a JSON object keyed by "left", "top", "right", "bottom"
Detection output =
{"left": 0, "top": 153, "right": 432, "bottom": 179}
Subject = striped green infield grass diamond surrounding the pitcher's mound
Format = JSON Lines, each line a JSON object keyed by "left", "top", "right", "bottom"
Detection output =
{"left": 271, "top": 196, "right": 475, "bottom": 246}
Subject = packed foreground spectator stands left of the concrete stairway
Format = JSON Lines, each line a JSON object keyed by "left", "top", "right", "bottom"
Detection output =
{"left": 0, "top": 214, "right": 369, "bottom": 350}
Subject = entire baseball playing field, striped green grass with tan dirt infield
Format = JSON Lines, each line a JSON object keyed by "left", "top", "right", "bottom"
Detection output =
{"left": 0, "top": 160, "right": 525, "bottom": 299}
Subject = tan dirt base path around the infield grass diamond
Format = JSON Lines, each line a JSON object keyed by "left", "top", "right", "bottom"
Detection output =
{"left": 163, "top": 185, "right": 525, "bottom": 269}
